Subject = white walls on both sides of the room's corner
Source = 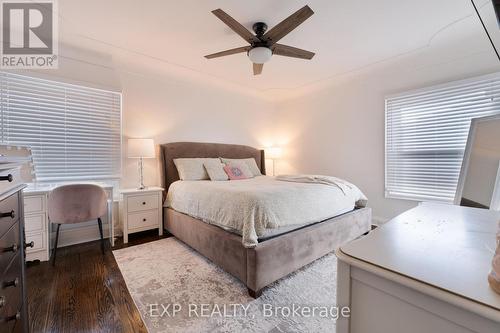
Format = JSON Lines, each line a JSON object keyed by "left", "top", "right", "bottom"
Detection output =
{"left": 15, "top": 29, "right": 499, "bottom": 220}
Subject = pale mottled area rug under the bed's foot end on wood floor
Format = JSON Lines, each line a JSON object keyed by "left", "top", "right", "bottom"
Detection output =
{"left": 113, "top": 237, "right": 338, "bottom": 333}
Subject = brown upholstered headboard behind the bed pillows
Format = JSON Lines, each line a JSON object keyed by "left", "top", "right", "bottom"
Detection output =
{"left": 160, "top": 142, "right": 266, "bottom": 193}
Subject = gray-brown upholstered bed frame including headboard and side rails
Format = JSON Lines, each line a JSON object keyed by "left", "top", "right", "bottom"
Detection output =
{"left": 160, "top": 142, "right": 371, "bottom": 298}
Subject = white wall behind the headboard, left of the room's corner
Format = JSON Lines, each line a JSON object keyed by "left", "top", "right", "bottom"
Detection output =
{"left": 14, "top": 46, "right": 274, "bottom": 187}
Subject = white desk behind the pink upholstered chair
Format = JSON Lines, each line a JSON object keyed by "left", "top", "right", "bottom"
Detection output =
{"left": 23, "top": 183, "right": 115, "bottom": 261}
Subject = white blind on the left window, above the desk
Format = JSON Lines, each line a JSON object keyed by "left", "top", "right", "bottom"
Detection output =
{"left": 0, "top": 72, "right": 121, "bottom": 182}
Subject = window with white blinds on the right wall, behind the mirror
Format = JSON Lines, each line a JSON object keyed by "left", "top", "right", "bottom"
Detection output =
{"left": 385, "top": 75, "right": 500, "bottom": 202}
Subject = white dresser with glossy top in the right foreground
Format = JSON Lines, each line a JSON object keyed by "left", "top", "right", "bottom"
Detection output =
{"left": 337, "top": 203, "right": 500, "bottom": 333}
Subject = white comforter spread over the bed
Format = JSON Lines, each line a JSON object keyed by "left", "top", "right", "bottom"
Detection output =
{"left": 165, "top": 176, "right": 366, "bottom": 247}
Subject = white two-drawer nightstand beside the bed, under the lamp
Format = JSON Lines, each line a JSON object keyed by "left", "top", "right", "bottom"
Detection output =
{"left": 120, "top": 187, "right": 163, "bottom": 244}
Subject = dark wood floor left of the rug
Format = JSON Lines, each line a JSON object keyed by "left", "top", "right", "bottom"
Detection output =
{"left": 26, "top": 231, "right": 169, "bottom": 333}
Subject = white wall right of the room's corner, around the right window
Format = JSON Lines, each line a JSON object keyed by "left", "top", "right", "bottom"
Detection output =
{"left": 276, "top": 52, "right": 499, "bottom": 221}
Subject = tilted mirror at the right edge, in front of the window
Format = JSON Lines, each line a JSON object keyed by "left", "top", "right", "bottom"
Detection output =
{"left": 455, "top": 115, "right": 500, "bottom": 210}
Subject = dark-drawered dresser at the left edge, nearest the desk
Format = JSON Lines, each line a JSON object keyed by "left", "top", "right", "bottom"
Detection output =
{"left": 0, "top": 169, "right": 28, "bottom": 333}
